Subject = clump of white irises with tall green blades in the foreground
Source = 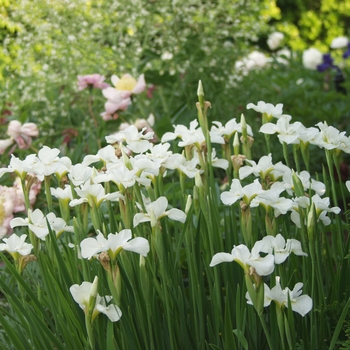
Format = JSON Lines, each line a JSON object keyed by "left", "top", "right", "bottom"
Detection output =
{"left": 0, "top": 69, "right": 350, "bottom": 349}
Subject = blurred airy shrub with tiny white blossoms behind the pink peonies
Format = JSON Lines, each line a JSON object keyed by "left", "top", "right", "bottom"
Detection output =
{"left": 1, "top": 0, "right": 266, "bottom": 136}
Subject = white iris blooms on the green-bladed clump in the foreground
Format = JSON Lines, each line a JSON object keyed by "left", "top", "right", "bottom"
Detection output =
{"left": 4, "top": 101, "right": 350, "bottom": 326}
